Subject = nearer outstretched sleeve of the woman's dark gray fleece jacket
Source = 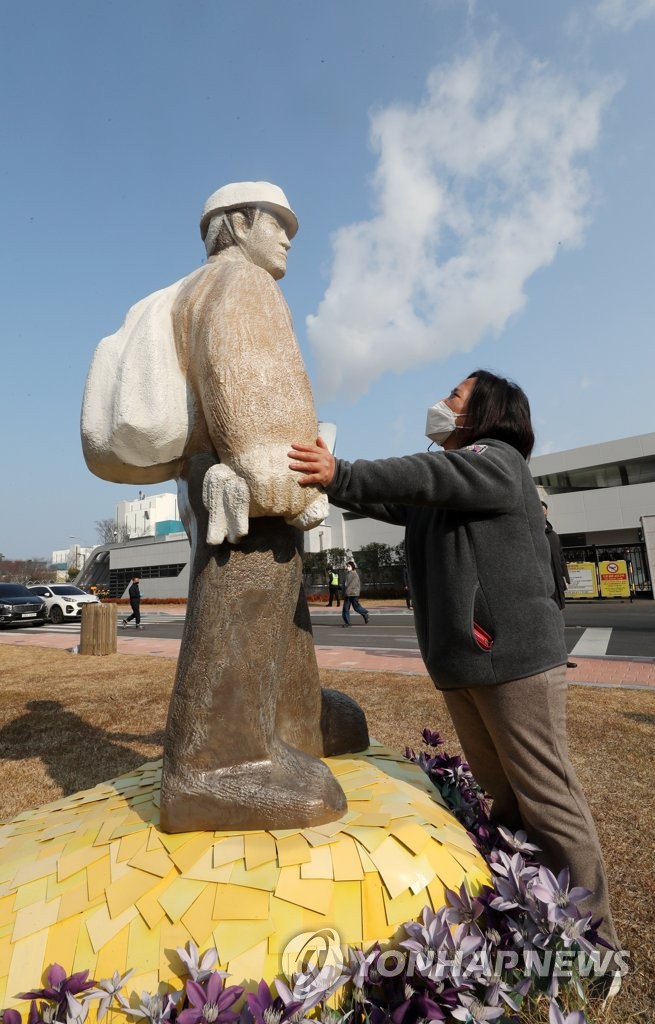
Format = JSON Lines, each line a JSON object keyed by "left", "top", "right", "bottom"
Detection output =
{"left": 325, "top": 441, "right": 522, "bottom": 515}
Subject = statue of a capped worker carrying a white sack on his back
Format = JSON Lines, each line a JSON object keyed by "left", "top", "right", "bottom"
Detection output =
{"left": 82, "top": 182, "right": 368, "bottom": 831}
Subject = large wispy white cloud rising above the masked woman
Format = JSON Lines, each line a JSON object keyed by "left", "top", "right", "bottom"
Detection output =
{"left": 307, "top": 45, "right": 615, "bottom": 397}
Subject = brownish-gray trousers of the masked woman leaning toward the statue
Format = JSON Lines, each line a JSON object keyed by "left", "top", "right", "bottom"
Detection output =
{"left": 441, "top": 666, "right": 619, "bottom": 948}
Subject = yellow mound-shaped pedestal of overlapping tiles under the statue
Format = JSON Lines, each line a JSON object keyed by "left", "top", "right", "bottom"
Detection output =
{"left": 0, "top": 745, "right": 489, "bottom": 1019}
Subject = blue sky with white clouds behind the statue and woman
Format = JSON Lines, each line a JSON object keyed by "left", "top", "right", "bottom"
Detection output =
{"left": 0, "top": 0, "right": 655, "bottom": 558}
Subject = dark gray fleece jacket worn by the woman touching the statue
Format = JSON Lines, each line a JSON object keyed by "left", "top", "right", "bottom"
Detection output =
{"left": 325, "top": 438, "right": 567, "bottom": 689}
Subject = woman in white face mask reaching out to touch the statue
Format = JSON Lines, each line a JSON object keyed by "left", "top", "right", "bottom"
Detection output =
{"left": 290, "top": 370, "right": 618, "bottom": 946}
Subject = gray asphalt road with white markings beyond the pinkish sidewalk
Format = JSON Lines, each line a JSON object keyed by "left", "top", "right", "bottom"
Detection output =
{"left": 20, "top": 601, "right": 655, "bottom": 658}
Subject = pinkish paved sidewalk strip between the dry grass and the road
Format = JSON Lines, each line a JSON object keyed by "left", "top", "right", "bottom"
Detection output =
{"left": 0, "top": 618, "right": 655, "bottom": 690}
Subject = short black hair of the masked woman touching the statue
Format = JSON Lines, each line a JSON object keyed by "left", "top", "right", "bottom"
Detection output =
{"left": 461, "top": 370, "right": 534, "bottom": 460}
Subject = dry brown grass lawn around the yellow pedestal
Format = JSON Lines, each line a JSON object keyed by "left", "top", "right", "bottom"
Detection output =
{"left": 0, "top": 646, "right": 655, "bottom": 1024}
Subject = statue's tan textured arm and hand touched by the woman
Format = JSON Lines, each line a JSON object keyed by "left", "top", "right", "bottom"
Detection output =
{"left": 194, "top": 264, "right": 328, "bottom": 528}
